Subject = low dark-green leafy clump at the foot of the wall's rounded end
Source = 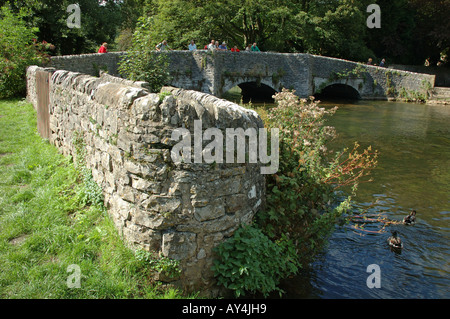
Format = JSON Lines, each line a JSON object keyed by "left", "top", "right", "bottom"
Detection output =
{"left": 213, "top": 226, "right": 299, "bottom": 297}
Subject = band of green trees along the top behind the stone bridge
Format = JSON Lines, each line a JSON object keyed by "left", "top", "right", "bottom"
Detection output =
{"left": 0, "top": 0, "right": 450, "bottom": 64}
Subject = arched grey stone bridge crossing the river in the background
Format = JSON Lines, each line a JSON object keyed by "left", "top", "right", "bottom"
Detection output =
{"left": 51, "top": 50, "right": 435, "bottom": 100}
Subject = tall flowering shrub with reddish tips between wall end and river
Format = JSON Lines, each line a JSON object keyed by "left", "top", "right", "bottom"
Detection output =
{"left": 256, "top": 90, "right": 377, "bottom": 259}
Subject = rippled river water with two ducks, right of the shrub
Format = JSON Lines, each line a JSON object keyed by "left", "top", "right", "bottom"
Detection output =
{"left": 223, "top": 90, "right": 450, "bottom": 299}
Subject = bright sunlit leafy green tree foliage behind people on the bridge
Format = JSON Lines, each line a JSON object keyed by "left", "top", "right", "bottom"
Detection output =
{"left": 137, "top": 0, "right": 373, "bottom": 60}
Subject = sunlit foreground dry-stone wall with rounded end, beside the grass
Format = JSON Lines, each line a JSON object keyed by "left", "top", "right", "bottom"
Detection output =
{"left": 27, "top": 67, "right": 265, "bottom": 296}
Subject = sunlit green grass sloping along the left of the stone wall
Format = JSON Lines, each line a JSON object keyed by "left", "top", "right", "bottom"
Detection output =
{"left": 0, "top": 100, "right": 190, "bottom": 299}
